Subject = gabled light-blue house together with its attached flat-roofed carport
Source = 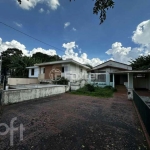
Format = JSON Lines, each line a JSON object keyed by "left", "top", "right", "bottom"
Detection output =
{"left": 89, "top": 60, "right": 150, "bottom": 99}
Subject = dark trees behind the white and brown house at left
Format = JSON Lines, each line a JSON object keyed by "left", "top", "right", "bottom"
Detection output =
{"left": 1, "top": 48, "right": 62, "bottom": 80}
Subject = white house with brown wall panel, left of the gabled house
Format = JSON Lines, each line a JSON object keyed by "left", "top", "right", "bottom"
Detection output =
{"left": 27, "top": 59, "right": 90, "bottom": 82}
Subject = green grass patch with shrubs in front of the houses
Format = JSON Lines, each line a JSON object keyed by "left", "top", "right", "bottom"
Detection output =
{"left": 71, "top": 84, "right": 116, "bottom": 98}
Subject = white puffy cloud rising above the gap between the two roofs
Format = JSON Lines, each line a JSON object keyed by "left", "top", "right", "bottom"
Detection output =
{"left": 62, "top": 42, "right": 104, "bottom": 66}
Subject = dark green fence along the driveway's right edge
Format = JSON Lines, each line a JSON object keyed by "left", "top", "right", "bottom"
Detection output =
{"left": 133, "top": 91, "right": 150, "bottom": 136}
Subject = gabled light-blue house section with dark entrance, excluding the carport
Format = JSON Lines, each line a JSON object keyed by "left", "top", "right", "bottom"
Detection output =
{"left": 89, "top": 60, "right": 132, "bottom": 87}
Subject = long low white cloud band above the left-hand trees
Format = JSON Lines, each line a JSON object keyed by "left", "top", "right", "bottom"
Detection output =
{"left": 0, "top": 38, "right": 57, "bottom": 56}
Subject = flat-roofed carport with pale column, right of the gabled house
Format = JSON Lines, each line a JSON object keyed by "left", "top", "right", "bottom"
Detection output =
{"left": 112, "top": 70, "right": 150, "bottom": 99}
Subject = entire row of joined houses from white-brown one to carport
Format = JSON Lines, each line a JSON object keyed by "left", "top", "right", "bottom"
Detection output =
{"left": 27, "top": 59, "right": 150, "bottom": 98}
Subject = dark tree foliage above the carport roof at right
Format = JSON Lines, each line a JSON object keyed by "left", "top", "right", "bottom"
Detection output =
{"left": 130, "top": 55, "right": 150, "bottom": 70}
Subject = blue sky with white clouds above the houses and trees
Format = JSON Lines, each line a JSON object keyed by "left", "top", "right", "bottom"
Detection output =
{"left": 0, "top": 0, "right": 150, "bottom": 65}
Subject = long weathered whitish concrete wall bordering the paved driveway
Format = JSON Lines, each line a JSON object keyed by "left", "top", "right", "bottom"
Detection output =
{"left": 1, "top": 85, "right": 69, "bottom": 105}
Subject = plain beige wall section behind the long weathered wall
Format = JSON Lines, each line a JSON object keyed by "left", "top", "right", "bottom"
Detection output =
{"left": 8, "top": 78, "right": 39, "bottom": 85}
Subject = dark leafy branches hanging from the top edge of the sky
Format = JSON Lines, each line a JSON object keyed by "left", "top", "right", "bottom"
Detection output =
{"left": 18, "top": 0, "right": 115, "bottom": 24}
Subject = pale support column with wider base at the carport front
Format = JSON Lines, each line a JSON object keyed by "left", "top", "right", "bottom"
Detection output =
{"left": 128, "top": 73, "right": 133, "bottom": 99}
